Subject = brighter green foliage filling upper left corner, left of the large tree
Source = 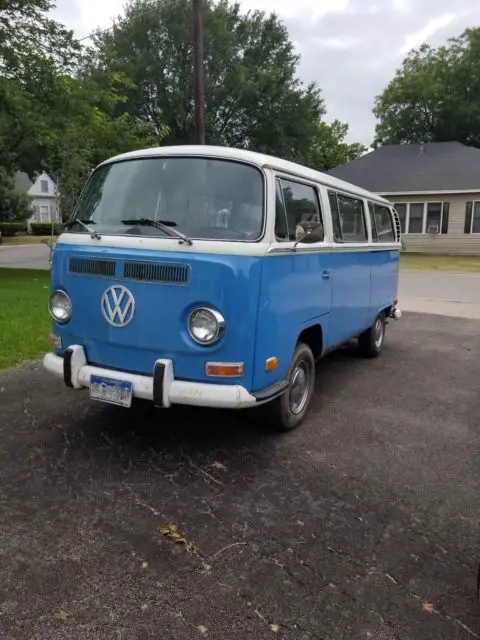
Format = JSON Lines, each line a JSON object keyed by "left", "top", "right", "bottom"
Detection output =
{"left": 0, "top": 0, "right": 169, "bottom": 215}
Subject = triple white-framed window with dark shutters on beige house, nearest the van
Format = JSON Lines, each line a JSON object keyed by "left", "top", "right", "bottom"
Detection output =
{"left": 394, "top": 202, "right": 450, "bottom": 234}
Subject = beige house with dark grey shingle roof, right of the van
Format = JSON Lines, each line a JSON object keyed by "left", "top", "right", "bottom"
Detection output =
{"left": 327, "top": 142, "right": 480, "bottom": 255}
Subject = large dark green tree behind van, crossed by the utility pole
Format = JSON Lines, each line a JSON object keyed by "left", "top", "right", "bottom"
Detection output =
{"left": 91, "top": 0, "right": 325, "bottom": 161}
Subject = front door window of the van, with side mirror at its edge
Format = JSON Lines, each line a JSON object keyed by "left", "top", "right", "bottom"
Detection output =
{"left": 275, "top": 178, "right": 323, "bottom": 241}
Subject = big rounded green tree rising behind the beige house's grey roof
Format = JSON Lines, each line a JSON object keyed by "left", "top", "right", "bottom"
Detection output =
{"left": 374, "top": 28, "right": 480, "bottom": 147}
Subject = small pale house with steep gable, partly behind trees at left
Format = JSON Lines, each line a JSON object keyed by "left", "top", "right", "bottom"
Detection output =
{"left": 14, "top": 172, "right": 60, "bottom": 227}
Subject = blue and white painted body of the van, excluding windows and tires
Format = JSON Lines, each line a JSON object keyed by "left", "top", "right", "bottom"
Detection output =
{"left": 44, "top": 147, "right": 400, "bottom": 424}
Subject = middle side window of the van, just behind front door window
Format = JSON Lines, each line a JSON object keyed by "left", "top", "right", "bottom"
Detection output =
{"left": 328, "top": 191, "right": 368, "bottom": 242}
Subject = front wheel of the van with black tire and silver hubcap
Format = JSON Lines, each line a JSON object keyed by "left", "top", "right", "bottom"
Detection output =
{"left": 264, "top": 342, "right": 315, "bottom": 431}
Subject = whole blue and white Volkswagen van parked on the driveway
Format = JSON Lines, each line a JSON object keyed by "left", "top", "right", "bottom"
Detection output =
{"left": 44, "top": 146, "right": 401, "bottom": 430}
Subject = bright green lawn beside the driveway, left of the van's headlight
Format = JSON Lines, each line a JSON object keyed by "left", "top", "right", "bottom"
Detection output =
{"left": 0, "top": 268, "right": 51, "bottom": 369}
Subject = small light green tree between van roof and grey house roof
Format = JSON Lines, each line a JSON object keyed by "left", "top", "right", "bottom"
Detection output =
{"left": 306, "top": 120, "right": 367, "bottom": 171}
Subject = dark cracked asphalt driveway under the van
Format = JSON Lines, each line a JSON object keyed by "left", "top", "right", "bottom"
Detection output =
{"left": 0, "top": 314, "right": 480, "bottom": 640}
